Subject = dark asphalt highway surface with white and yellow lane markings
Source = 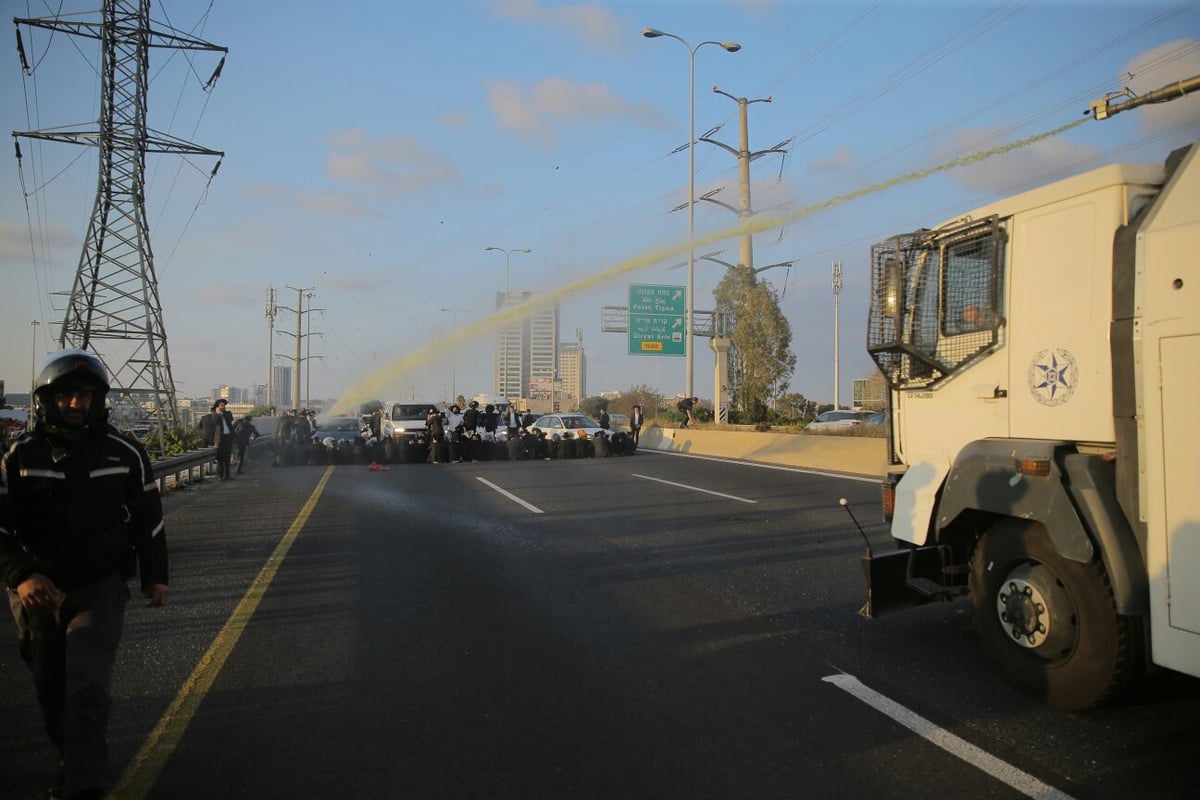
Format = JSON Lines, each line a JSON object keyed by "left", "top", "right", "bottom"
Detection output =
{"left": 0, "top": 452, "right": 1200, "bottom": 800}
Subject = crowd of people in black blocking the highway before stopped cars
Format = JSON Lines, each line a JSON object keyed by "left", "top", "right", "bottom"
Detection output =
{"left": 261, "top": 401, "right": 643, "bottom": 471}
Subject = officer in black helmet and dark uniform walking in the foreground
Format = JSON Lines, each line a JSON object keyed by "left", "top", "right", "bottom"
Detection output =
{"left": 0, "top": 350, "right": 168, "bottom": 798}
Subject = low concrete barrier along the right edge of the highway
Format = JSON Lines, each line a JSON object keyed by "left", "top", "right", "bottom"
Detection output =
{"left": 641, "top": 426, "right": 888, "bottom": 477}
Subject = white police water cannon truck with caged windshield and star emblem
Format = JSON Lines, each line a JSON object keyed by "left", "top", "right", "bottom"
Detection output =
{"left": 864, "top": 145, "right": 1200, "bottom": 709}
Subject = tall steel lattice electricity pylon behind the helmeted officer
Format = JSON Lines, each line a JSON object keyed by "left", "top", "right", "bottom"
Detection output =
{"left": 13, "top": 0, "right": 228, "bottom": 450}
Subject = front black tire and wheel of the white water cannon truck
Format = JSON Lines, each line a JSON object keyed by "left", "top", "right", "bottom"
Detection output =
{"left": 970, "top": 519, "right": 1144, "bottom": 710}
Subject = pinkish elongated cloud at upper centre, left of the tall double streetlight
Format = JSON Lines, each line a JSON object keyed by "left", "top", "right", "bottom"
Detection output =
{"left": 487, "top": 78, "right": 671, "bottom": 146}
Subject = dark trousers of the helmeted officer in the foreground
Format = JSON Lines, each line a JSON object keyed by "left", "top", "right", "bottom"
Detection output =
{"left": 8, "top": 572, "right": 130, "bottom": 796}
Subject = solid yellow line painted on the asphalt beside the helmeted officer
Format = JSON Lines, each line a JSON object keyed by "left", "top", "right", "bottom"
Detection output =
{"left": 109, "top": 467, "right": 334, "bottom": 800}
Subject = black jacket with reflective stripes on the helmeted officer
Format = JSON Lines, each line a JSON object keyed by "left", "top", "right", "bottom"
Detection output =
{"left": 0, "top": 425, "right": 167, "bottom": 589}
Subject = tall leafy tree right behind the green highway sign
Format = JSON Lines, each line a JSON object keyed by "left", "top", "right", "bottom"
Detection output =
{"left": 713, "top": 266, "right": 796, "bottom": 422}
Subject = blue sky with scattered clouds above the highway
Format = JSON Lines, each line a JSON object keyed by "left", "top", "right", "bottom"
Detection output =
{"left": 0, "top": 0, "right": 1200, "bottom": 403}
